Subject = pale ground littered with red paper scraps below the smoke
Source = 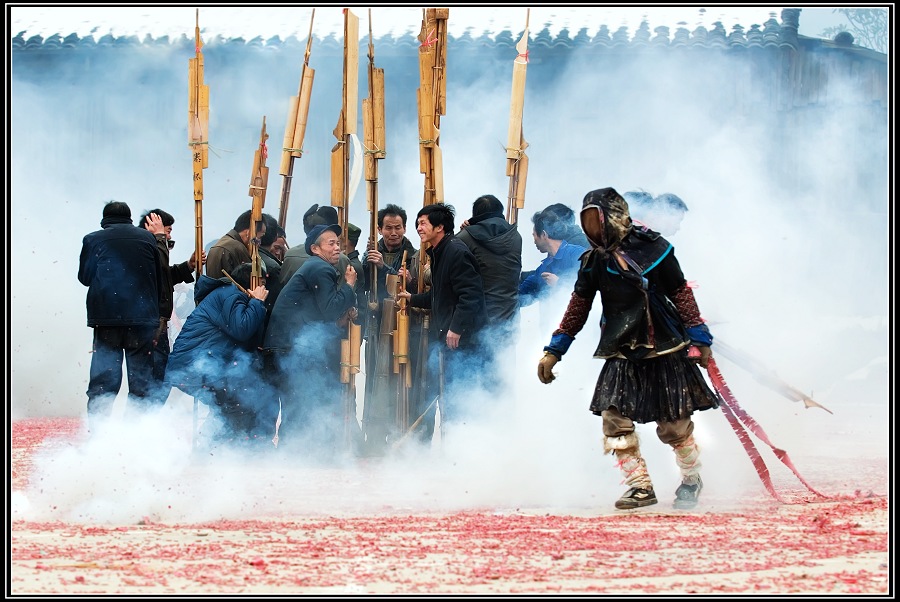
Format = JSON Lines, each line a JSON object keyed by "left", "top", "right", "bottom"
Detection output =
{"left": 11, "top": 419, "right": 889, "bottom": 595}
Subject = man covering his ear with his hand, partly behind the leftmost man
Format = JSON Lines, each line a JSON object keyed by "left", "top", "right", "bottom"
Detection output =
{"left": 138, "top": 209, "right": 206, "bottom": 405}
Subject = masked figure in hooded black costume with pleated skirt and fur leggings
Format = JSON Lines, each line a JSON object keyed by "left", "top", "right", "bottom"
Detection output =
{"left": 538, "top": 188, "right": 719, "bottom": 509}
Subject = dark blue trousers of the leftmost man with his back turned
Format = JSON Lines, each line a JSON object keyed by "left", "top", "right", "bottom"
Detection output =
{"left": 87, "top": 326, "right": 156, "bottom": 416}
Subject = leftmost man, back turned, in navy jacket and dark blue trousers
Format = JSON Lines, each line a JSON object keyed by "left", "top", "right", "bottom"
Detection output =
{"left": 78, "top": 201, "right": 168, "bottom": 431}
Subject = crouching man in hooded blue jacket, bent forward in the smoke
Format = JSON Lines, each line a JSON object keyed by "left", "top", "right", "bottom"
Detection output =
{"left": 166, "top": 263, "right": 268, "bottom": 445}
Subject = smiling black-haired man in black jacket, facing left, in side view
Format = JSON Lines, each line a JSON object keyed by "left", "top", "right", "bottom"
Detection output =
{"left": 398, "top": 203, "right": 493, "bottom": 440}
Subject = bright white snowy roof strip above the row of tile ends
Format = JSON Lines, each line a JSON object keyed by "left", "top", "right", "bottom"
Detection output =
{"left": 7, "top": 4, "right": 782, "bottom": 41}
